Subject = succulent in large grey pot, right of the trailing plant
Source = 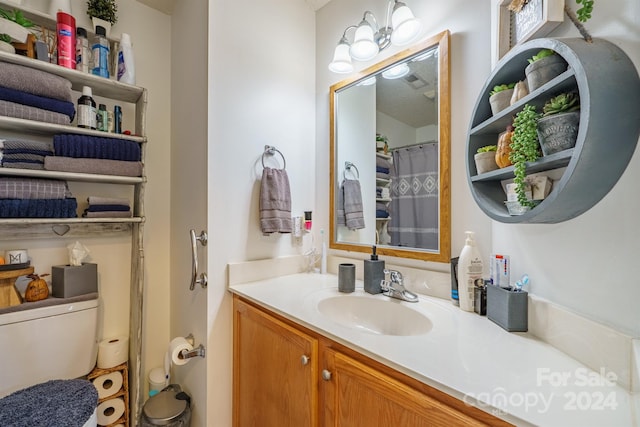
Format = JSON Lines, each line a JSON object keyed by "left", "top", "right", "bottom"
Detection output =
{"left": 538, "top": 91, "right": 580, "bottom": 156}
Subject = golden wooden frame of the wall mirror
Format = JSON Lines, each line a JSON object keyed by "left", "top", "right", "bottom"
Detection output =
{"left": 329, "top": 30, "right": 451, "bottom": 263}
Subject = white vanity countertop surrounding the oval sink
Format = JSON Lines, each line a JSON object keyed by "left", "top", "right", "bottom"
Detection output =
{"left": 229, "top": 273, "right": 638, "bottom": 427}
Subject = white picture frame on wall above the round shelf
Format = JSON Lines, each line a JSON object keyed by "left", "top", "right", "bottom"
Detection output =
{"left": 496, "top": 0, "right": 564, "bottom": 59}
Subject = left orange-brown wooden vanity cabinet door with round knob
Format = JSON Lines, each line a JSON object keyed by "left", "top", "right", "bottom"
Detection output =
{"left": 233, "top": 297, "right": 318, "bottom": 427}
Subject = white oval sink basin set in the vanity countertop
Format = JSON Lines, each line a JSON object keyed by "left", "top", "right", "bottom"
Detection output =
{"left": 318, "top": 295, "right": 433, "bottom": 336}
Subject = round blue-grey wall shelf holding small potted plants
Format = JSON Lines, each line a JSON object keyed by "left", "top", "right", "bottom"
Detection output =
{"left": 466, "top": 38, "right": 640, "bottom": 223}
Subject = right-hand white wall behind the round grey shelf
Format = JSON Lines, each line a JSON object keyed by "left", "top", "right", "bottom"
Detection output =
{"left": 490, "top": 0, "right": 640, "bottom": 336}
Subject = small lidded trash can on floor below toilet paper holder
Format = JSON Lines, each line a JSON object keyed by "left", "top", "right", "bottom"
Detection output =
{"left": 140, "top": 384, "right": 191, "bottom": 427}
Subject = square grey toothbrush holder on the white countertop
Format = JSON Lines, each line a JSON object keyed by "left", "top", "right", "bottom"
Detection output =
{"left": 487, "top": 285, "right": 529, "bottom": 332}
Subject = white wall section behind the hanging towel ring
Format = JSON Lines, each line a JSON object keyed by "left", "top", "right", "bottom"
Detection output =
{"left": 208, "top": 0, "right": 318, "bottom": 426}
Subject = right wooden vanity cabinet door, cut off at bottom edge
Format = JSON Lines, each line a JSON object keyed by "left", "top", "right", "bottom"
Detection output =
{"left": 321, "top": 348, "right": 486, "bottom": 427}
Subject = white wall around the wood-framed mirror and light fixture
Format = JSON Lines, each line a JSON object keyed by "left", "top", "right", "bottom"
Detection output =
{"left": 316, "top": 0, "right": 491, "bottom": 272}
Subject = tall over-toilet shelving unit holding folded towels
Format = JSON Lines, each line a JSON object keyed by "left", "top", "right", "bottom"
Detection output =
{"left": 0, "top": 42, "right": 147, "bottom": 424}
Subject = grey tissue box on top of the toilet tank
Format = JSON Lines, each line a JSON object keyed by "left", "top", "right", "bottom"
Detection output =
{"left": 51, "top": 263, "right": 98, "bottom": 298}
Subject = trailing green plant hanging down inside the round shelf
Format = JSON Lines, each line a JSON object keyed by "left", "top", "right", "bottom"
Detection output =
{"left": 509, "top": 104, "right": 540, "bottom": 207}
